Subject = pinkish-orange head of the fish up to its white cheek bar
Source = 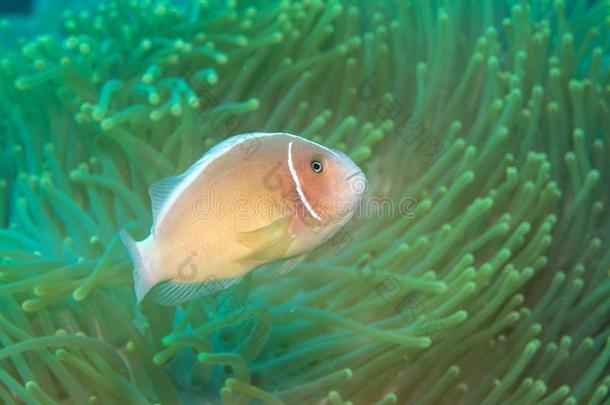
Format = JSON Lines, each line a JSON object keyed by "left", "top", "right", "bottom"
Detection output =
{"left": 291, "top": 138, "right": 367, "bottom": 222}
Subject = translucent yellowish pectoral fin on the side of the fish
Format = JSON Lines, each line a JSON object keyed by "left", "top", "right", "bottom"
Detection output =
{"left": 237, "top": 217, "right": 294, "bottom": 260}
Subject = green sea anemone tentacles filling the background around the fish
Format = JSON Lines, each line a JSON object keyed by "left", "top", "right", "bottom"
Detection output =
{"left": 0, "top": 0, "right": 610, "bottom": 405}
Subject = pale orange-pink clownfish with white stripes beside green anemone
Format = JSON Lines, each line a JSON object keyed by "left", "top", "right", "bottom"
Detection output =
{"left": 121, "top": 133, "right": 366, "bottom": 305}
